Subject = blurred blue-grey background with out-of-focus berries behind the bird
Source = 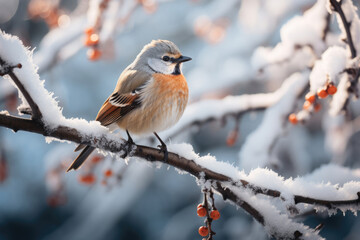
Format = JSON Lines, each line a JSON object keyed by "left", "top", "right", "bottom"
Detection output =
{"left": 0, "top": 0, "right": 360, "bottom": 240}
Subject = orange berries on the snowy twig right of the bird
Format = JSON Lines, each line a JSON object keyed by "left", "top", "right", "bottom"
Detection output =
{"left": 289, "top": 82, "right": 337, "bottom": 125}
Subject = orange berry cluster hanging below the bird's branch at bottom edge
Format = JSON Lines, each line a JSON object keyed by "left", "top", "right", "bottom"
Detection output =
{"left": 197, "top": 190, "right": 220, "bottom": 240}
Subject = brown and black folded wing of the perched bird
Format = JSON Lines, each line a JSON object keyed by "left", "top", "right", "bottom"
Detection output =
{"left": 96, "top": 71, "right": 151, "bottom": 126}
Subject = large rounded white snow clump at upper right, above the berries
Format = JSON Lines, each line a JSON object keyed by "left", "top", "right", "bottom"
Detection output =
{"left": 252, "top": 0, "right": 329, "bottom": 78}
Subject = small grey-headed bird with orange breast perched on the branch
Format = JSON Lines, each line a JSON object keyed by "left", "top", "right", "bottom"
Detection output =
{"left": 67, "top": 40, "right": 191, "bottom": 172}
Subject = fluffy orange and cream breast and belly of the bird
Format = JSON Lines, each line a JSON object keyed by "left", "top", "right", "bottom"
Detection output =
{"left": 118, "top": 73, "right": 189, "bottom": 134}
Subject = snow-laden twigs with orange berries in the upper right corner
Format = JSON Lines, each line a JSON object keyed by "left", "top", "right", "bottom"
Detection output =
{"left": 252, "top": 0, "right": 360, "bottom": 129}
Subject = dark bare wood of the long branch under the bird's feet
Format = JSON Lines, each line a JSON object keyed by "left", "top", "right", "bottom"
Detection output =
{"left": 0, "top": 111, "right": 360, "bottom": 218}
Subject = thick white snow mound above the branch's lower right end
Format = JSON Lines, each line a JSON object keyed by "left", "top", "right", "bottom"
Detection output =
{"left": 240, "top": 164, "right": 360, "bottom": 206}
